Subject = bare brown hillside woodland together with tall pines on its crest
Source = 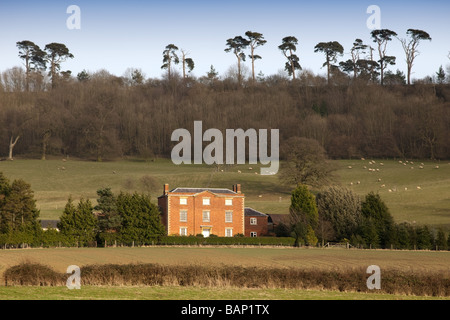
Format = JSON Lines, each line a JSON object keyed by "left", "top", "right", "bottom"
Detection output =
{"left": 0, "top": 29, "right": 450, "bottom": 161}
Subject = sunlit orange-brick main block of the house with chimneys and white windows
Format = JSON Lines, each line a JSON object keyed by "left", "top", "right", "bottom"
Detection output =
{"left": 158, "top": 184, "right": 245, "bottom": 237}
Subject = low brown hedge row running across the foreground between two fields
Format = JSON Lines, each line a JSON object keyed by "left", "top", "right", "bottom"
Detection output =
{"left": 4, "top": 262, "right": 450, "bottom": 297}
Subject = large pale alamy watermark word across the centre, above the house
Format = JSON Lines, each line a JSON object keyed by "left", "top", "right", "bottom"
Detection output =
{"left": 171, "top": 121, "right": 280, "bottom": 175}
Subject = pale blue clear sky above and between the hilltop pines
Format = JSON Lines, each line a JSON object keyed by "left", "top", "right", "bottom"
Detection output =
{"left": 0, "top": 0, "right": 450, "bottom": 78}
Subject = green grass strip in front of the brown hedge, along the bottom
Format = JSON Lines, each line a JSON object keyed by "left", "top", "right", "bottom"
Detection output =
{"left": 0, "top": 286, "right": 450, "bottom": 301}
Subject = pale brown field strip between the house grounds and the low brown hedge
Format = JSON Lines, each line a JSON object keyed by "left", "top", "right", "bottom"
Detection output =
{"left": 0, "top": 247, "right": 450, "bottom": 284}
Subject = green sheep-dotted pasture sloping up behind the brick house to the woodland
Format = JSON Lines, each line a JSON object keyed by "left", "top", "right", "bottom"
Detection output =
{"left": 0, "top": 159, "right": 450, "bottom": 230}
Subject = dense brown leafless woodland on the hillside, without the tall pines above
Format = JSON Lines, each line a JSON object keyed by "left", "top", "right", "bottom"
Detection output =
{"left": 0, "top": 73, "right": 450, "bottom": 161}
